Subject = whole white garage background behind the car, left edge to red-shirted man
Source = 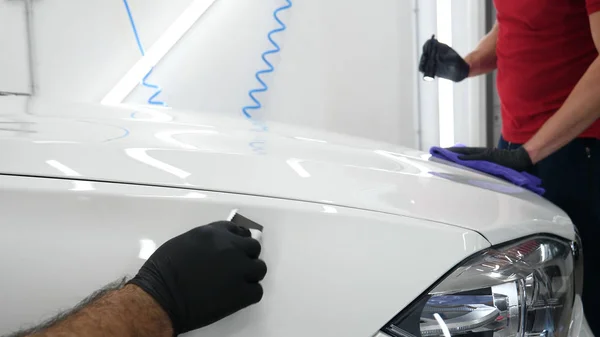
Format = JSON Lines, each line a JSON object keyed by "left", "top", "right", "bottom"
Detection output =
{"left": 0, "top": 0, "right": 500, "bottom": 149}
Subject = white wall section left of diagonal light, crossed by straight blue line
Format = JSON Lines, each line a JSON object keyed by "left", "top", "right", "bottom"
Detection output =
{"left": 30, "top": 0, "right": 189, "bottom": 101}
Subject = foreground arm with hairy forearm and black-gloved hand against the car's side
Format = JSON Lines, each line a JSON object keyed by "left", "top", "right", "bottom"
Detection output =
{"left": 6, "top": 221, "right": 267, "bottom": 337}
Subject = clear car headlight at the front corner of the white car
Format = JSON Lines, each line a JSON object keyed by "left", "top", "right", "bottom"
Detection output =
{"left": 381, "top": 237, "right": 582, "bottom": 337}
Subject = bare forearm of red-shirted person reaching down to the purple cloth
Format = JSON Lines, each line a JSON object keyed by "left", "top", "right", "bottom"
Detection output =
{"left": 523, "top": 12, "right": 600, "bottom": 163}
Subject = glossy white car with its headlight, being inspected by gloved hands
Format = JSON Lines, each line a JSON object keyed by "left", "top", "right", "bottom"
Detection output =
{"left": 0, "top": 97, "right": 592, "bottom": 337}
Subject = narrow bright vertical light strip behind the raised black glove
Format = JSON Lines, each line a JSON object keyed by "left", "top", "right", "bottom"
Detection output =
{"left": 436, "top": 0, "right": 454, "bottom": 147}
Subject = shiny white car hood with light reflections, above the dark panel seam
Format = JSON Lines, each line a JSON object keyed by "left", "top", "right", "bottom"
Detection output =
{"left": 0, "top": 97, "right": 573, "bottom": 243}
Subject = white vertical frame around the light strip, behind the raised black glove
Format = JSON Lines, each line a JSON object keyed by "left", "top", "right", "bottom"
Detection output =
{"left": 413, "top": 0, "right": 487, "bottom": 150}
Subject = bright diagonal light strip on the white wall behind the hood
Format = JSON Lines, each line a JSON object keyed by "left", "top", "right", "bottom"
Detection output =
{"left": 100, "top": 0, "right": 216, "bottom": 105}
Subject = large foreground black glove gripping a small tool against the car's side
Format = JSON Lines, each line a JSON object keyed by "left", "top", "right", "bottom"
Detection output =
{"left": 129, "top": 221, "right": 267, "bottom": 335}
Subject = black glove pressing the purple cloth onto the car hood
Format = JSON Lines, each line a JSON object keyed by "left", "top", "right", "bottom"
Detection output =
{"left": 448, "top": 147, "right": 533, "bottom": 172}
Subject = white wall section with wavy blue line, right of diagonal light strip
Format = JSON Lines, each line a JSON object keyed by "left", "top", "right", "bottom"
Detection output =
{"left": 127, "top": 0, "right": 417, "bottom": 147}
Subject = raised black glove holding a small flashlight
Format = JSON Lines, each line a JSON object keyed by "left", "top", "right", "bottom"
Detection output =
{"left": 419, "top": 35, "right": 470, "bottom": 82}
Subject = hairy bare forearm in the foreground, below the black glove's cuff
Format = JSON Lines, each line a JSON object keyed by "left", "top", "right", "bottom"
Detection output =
{"left": 7, "top": 279, "right": 173, "bottom": 337}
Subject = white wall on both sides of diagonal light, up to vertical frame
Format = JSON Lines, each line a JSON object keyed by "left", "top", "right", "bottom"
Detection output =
{"left": 0, "top": 0, "right": 418, "bottom": 147}
